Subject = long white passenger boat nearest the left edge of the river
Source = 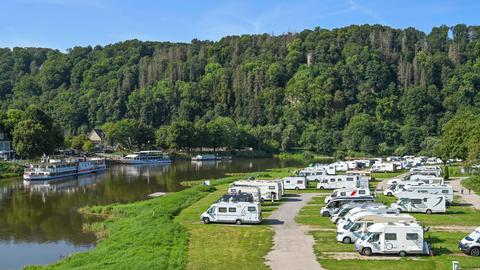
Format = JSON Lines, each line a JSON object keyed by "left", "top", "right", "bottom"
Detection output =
{"left": 23, "top": 156, "right": 106, "bottom": 182}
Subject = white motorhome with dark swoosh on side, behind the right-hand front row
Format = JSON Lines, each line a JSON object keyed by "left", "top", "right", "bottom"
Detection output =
{"left": 391, "top": 193, "right": 447, "bottom": 214}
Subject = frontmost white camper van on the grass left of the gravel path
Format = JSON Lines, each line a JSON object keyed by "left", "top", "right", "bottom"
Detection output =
{"left": 200, "top": 202, "right": 262, "bottom": 225}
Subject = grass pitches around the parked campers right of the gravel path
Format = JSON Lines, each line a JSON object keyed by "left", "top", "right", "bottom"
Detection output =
{"left": 296, "top": 194, "right": 480, "bottom": 270}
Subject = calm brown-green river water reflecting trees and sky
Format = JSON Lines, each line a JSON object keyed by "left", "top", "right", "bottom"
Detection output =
{"left": 0, "top": 158, "right": 301, "bottom": 270}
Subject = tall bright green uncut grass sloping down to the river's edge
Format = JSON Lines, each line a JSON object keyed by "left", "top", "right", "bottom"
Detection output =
{"left": 27, "top": 186, "right": 213, "bottom": 270}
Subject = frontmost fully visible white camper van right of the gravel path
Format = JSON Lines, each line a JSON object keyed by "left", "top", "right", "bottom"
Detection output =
{"left": 355, "top": 223, "right": 430, "bottom": 257}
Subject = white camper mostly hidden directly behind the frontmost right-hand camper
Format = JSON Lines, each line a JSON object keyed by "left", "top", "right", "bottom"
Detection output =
{"left": 337, "top": 212, "right": 417, "bottom": 244}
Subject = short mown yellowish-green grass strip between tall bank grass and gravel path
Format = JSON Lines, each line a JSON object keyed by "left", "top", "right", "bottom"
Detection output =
{"left": 175, "top": 185, "right": 275, "bottom": 269}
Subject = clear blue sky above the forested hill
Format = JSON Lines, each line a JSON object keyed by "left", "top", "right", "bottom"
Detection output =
{"left": 0, "top": 0, "right": 480, "bottom": 50}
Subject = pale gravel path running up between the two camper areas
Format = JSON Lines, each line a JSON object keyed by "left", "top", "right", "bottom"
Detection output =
{"left": 266, "top": 193, "right": 323, "bottom": 270}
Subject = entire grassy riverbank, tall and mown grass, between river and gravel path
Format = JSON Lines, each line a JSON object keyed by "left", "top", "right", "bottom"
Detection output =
{"left": 26, "top": 168, "right": 293, "bottom": 270}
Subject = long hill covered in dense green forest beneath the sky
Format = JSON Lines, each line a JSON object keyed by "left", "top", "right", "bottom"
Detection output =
{"left": 0, "top": 24, "right": 480, "bottom": 157}
